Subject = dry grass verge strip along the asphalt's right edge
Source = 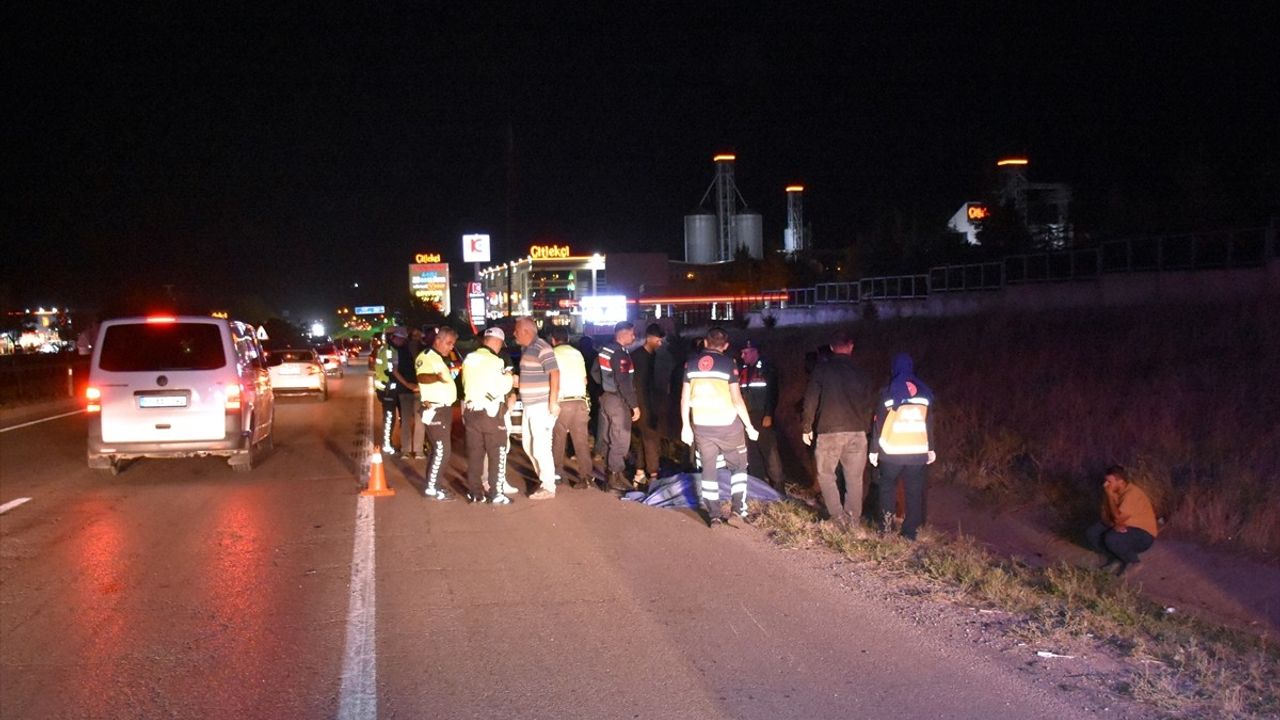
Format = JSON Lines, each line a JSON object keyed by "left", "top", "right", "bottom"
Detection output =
{"left": 756, "top": 502, "right": 1280, "bottom": 719}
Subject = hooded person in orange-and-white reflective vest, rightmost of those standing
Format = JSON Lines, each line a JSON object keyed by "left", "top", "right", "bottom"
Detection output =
{"left": 868, "top": 352, "right": 937, "bottom": 539}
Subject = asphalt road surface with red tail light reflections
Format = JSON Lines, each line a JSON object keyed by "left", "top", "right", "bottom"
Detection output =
{"left": 0, "top": 370, "right": 1092, "bottom": 719}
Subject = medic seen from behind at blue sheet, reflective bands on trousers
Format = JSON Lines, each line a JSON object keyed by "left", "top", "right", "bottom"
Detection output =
{"left": 680, "top": 328, "right": 760, "bottom": 525}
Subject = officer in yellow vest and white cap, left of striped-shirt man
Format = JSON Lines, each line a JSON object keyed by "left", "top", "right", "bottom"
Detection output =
{"left": 462, "top": 328, "right": 515, "bottom": 505}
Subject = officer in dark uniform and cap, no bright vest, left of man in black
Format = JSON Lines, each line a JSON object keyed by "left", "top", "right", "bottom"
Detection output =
{"left": 591, "top": 320, "right": 640, "bottom": 492}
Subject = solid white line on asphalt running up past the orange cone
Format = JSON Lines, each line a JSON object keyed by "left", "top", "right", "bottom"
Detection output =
{"left": 338, "top": 378, "right": 378, "bottom": 720}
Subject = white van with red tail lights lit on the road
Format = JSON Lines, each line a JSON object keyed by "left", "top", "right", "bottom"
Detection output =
{"left": 86, "top": 315, "right": 275, "bottom": 475}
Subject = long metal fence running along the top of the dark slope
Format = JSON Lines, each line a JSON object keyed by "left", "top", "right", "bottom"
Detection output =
{"left": 755, "top": 225, "right": 1280, "bottom": 309}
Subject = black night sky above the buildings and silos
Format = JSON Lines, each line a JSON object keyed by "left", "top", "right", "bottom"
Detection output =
{"left": 0, "top": 3, "right": 1280, "bottom": 313}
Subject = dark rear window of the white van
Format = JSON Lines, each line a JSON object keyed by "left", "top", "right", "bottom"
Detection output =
{"left": 97, "top": 323, "right": 227, "bottom": 373}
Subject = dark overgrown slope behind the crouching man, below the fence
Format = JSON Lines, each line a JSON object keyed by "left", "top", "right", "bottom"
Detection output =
{"left": 751, "top": 301, "right": 1280, "bottom": 553}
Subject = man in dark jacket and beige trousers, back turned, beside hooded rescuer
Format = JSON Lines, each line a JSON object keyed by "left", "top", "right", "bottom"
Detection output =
{"left": 800, "top": 331, "right": 872, "bottom": 525}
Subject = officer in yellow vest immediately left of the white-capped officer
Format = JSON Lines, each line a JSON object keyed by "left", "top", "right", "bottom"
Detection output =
{"left": 413, "top": 325, "right": 458, "bottom": 501}
